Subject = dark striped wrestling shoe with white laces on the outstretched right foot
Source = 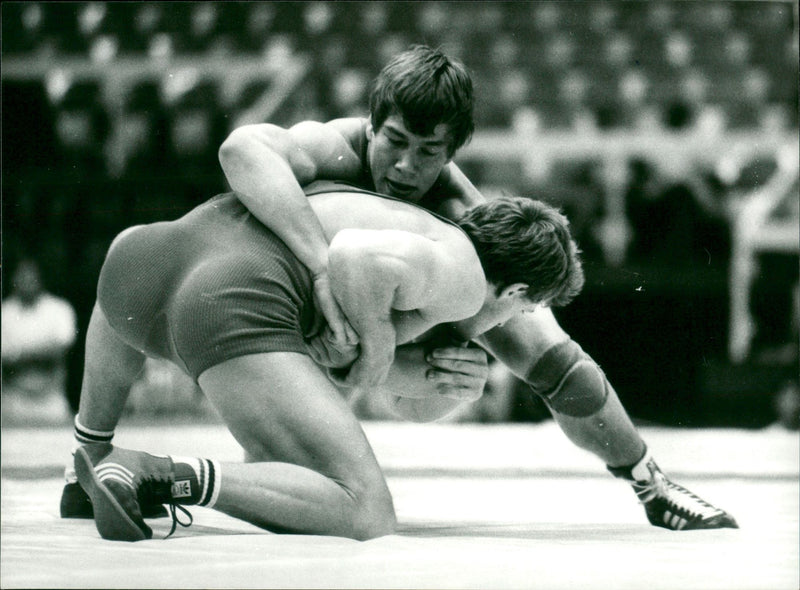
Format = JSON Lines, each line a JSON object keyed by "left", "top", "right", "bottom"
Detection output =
{"left": 608, "top": 453, "right": 739, "bottom": 531}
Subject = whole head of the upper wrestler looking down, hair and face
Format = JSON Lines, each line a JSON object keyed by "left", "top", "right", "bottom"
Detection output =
{"left": 367, "top": 45, "right": 474, "bottom": 201}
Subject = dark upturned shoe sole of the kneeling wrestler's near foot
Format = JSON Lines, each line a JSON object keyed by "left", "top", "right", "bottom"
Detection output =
{"left": 75, "top": 449, "right": 148, "bottom": 542}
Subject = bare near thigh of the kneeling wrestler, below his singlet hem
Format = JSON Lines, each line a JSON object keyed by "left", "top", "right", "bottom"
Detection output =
{"left": 198, "top": 352, "right": 384, "bottom": 485}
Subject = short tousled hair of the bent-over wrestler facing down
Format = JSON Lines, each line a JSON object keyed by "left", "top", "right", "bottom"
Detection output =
{"left": 458, "top": 197, "right": 584, "bottom": 307}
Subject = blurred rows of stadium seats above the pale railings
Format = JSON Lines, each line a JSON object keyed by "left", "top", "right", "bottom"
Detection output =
{"left": 3, "top": 0, "right": 797, "bottom": 128}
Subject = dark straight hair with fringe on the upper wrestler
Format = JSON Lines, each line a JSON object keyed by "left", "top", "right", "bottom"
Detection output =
{"left": 369, "top": 45, "right": 475, "bottom": 156}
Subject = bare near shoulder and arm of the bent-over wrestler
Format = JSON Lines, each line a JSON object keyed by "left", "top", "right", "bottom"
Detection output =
{"left": 329, "top": 229, "right": 485, "bottom": 386}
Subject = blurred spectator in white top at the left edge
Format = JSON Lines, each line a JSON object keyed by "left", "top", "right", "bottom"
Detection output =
{"left": 2, "top": 259, "right": 76, "bottom": 426}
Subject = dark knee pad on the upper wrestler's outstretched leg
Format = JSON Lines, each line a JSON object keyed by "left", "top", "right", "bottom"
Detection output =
{"left": 525, "top": 340, "right": 608, "bottom": 418}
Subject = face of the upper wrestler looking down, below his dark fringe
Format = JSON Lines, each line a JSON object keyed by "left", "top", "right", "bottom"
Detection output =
{"left": 367, "top": 114, "right": 450, "bottom": 202}
